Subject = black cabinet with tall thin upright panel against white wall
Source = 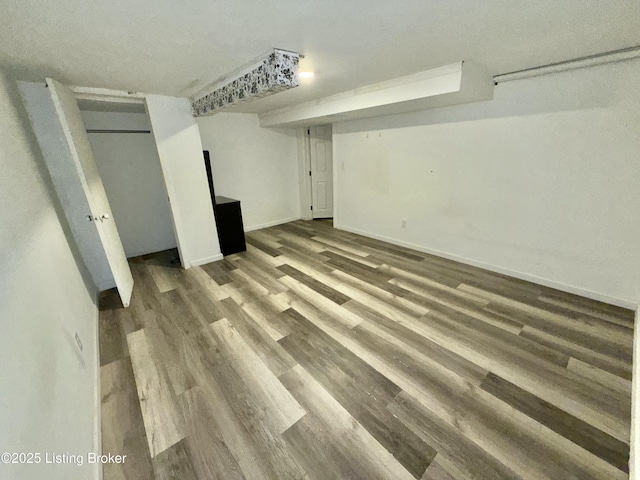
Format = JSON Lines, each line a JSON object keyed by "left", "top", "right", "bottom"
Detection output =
{"left": 203, "top": 150, "right": 247, "bottom": 255}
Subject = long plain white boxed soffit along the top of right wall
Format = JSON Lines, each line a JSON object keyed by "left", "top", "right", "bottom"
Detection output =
{"left": 260, "top": 61, "right": 494, "bottom": 127}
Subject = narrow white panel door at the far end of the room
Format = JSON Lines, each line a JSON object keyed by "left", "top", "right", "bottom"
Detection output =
{"left": 309, "top": 125, "right": 333, "bottom": 218}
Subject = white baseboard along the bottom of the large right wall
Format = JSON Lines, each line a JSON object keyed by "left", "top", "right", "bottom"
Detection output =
{"left": 334, "top": 223, "right": 638, "bottom": 310}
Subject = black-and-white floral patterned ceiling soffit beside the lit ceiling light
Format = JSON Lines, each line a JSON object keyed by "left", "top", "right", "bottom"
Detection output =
{"left": 191, "top": 49, "right": 300, "bottom": 117}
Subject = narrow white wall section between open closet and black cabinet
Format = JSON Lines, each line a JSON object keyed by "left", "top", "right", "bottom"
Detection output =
{"left": 146, "top": 95, "right": 222, "bottom": 268}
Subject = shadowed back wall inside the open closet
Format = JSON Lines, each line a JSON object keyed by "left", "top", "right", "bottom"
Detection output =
{"left": 82, "top": 111, "right": 176, "bottom": 257}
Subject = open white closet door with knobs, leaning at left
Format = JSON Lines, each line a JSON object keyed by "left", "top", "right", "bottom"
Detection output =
{"left": 19, "top": 78, "right": 133, "bottom": 307}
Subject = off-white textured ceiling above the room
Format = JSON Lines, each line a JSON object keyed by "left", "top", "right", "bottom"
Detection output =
{"left": 0, "top": 0, "right": 640, "bottom": 112}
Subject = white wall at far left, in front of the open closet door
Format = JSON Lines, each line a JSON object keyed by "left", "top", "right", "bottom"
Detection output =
{"left": 0, "top": 72, "right": 99, "bottom": 480}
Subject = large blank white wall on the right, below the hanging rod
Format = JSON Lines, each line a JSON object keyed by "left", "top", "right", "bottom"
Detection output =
{"left": 333, "top": 61, "right": 640, "bottom": 306}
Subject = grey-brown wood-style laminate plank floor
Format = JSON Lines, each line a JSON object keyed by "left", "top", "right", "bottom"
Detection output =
{"left": 100, "top": 221, "right": 633, "bottom": 480}
